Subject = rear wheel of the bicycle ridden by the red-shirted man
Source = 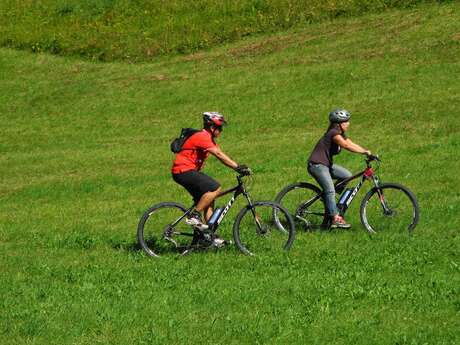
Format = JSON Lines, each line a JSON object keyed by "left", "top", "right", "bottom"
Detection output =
{"left": 137, "top": 202, "right": 193, "bottom": 257}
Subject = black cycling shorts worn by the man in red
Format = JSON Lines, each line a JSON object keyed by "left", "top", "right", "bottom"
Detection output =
{"left": 173, "top": 170, "right": 220, "bottom": 204}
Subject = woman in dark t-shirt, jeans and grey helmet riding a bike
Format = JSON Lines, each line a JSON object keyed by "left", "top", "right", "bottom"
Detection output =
{"left": 308, "top": 109, "right": 371, "bottom": 229}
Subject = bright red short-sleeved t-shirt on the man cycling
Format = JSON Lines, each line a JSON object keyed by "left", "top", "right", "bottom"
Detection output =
{"left": 171, "top": 129, "right": 217, "bottom": 174}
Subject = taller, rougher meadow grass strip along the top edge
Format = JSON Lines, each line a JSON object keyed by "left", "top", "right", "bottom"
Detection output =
{"left": 0, "top": 0, "right": 449, "bottom": 62}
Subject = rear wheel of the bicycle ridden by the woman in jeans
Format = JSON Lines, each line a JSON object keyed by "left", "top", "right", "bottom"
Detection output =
{"left": 273, "top": 182, "right": 327, "bottom": 231}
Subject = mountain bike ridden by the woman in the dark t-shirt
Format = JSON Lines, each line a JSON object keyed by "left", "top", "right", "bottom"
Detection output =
{"left": 273, "top": 155, "right": 419, "bottom": 234}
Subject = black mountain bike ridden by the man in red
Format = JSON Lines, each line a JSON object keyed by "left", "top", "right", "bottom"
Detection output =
{"left": 137, "top": 173, "right": 295, "bottom": 257}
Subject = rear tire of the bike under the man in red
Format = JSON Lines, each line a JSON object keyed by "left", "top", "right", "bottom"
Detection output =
{"left": 137, "top": 202, "right": 190, "bottom": 257}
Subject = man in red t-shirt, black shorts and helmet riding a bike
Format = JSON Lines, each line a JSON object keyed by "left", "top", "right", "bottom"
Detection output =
{"left": 171, "top": 112, "right": 248, "bottom": 230}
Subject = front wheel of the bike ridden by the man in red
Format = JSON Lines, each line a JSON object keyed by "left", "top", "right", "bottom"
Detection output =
{"left": 233, "top": 201, "right": 295, "bottom": 255}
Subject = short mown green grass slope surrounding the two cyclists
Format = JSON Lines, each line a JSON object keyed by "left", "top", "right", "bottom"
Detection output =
{"left": 0, "top": 2, "right": 460, "bottom": 345}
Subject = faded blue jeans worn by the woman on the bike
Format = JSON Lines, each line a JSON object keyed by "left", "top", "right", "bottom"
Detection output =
{"left": 308, "top": 163, "right": 352, "bottom": 217}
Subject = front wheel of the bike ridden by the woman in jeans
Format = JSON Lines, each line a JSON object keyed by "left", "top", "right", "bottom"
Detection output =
{"left": 360, "top": 183, "right": 419, "bottom": 234}
